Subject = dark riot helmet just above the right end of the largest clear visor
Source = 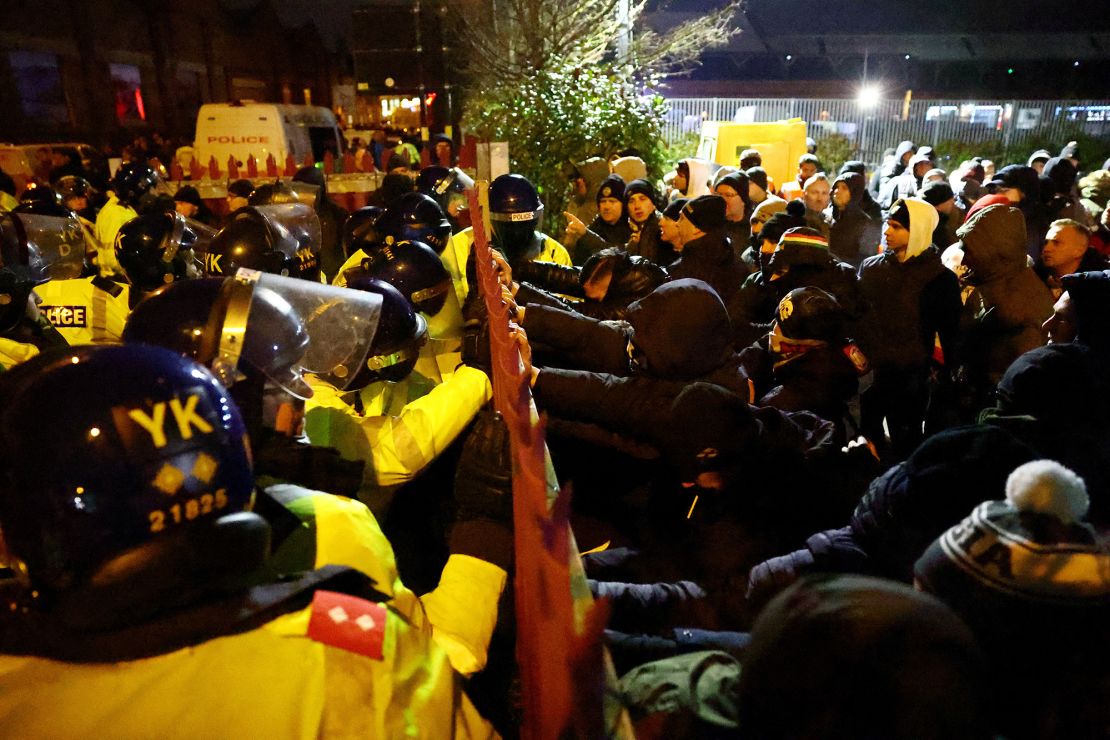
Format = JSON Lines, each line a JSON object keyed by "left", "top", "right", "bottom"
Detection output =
{"left": 345, "top": 242, "right": 451, "bottom": 316}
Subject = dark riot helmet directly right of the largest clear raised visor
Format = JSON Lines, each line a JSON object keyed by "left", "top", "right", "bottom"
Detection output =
{"left": 347, "top": 275, "right": 427, "bottom": 389}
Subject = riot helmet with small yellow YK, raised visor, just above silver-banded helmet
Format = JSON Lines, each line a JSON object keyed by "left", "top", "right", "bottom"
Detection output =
{"left": 204, "top": 203, "right": 320, "bottom": 281}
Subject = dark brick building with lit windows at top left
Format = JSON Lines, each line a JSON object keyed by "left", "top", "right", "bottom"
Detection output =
{"left": 0, "top": 0, "right": 336, "bottom": 144}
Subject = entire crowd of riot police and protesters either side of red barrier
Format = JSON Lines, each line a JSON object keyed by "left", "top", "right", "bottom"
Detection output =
{"left": 0, "top": 130, "right": 1110, "bottom": 740}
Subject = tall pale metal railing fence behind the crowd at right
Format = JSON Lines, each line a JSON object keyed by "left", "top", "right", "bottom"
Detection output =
{"left": 664, "top": 98, "right": 1110, "bottom": 163}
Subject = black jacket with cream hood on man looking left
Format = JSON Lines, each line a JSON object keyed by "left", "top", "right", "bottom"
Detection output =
{"left": 854, "top": 197, "right": 961, "bottom": 373}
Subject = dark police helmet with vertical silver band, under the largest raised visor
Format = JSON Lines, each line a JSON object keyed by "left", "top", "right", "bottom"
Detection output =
{"left": 123, "top": 277, "right": 311, "bottom": 395}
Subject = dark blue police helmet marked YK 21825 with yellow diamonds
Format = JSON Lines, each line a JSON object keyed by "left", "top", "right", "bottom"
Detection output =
{"left": 0, "top": 345, "right": 255, "bottom": 603}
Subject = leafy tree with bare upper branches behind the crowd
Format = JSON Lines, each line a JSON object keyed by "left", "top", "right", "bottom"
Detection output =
{"left": 451, "top": 0, "right": 740, "bottom": 227}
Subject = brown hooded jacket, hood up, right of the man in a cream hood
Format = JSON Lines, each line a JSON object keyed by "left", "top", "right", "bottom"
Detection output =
{"left": 956, "top": 205, "right": 1053, "bottom": 385}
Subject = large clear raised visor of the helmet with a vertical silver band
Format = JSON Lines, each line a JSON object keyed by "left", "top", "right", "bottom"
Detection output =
{"left": 235, "top": 270, "right": 382, "bottom": 398}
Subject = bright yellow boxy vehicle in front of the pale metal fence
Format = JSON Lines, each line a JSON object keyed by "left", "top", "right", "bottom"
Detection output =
{"left": 697, "top": 119, "right": 806, "bottom": 188}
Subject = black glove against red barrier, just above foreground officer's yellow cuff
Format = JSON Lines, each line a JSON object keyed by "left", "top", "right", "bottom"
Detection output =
{"left": 455, "top": 409, "right": 513, "bottom": 526}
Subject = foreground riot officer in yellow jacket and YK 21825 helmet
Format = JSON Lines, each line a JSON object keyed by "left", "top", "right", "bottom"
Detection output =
{"left": 0, "top": 346, "right": 506, "bottom": 738}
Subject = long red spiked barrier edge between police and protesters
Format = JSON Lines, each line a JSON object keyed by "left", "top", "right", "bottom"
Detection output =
{"left": 467, "top": 190, "right": 608, "bottom": 740}
